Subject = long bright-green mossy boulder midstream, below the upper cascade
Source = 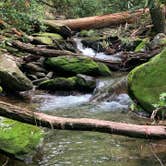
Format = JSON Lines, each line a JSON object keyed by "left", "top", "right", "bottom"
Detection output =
{"left": 45, "top": 56, "right": 111, "bottom": 76}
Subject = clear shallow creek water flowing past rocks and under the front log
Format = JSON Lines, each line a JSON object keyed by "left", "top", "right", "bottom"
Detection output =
{"left": 0, "top": 38, "right": 166, "bottom": 166}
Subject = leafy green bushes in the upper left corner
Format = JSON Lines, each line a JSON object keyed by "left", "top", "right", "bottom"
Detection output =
{"left": 0, "top": 0, "right": 44, "bottom": 33}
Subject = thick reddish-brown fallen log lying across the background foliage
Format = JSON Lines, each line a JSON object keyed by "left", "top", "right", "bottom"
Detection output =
{"left": 45, "top": 9, "right": 149, "bottom": 30}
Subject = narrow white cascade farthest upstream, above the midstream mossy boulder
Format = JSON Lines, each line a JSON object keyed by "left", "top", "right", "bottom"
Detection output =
{"left": 74, "top": 38, "right": 121, "bottom": 62}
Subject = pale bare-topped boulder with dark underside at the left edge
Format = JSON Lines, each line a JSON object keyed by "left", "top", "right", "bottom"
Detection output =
{"left": 0, "top": 54, "right": 33, "bottom": 91}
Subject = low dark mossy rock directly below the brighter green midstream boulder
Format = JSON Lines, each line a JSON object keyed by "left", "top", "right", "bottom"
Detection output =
{"left": 38, "top": 75, "right": 96, "bottom": 92}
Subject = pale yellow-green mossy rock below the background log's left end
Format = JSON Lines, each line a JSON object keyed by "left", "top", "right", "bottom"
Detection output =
{"left": 34, "top": 32, "right": 63, "bottom": 45}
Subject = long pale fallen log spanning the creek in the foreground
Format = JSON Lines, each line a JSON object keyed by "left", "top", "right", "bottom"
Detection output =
{"left": 0, "top": 101, "right": 166, "bottom": 139}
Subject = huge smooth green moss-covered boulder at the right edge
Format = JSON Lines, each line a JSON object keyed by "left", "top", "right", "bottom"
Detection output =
{"left": 128, "top": 49, "right": 166, "bottom": 112}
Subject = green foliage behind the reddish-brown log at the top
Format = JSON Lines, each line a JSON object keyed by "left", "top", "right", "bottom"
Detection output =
{"left": 52, "top": 0, "right": 145, "bottom": 17}
